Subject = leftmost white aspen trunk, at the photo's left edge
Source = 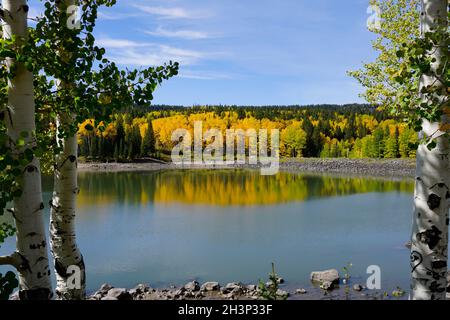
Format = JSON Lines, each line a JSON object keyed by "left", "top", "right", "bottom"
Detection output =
{"left": 0, "top": 0, "right": 52, "bottom": 300}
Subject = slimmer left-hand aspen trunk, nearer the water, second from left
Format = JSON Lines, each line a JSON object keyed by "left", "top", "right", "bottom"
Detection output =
{"left": 50, "top": 0, "right": 86, "bottom": 300}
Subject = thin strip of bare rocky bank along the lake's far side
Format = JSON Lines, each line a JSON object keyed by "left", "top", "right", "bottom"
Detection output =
{"left": 78, "top": 158, "right": 415, "bottom": 178}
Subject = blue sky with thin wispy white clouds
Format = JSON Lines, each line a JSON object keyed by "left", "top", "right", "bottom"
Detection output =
{"left": 32, "top": 0, "right": 374, "bottom": 105}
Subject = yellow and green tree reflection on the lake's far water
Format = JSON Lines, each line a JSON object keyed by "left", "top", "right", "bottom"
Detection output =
{"left": 78, "top": 170, "right": 414, "bottom": 206}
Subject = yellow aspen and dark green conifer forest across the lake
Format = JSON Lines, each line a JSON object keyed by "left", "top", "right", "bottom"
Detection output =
{"left": 79, "top": 104, "right": 418, "bottom": 161}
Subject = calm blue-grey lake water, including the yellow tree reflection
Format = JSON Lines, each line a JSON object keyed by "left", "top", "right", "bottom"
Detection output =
{"left": 0, "top": 170, "right": 413, "bottom": 291}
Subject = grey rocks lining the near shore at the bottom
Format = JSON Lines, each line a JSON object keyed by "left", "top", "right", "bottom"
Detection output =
{"left": 84, "top": 269, "right": 432, "bottom": 300}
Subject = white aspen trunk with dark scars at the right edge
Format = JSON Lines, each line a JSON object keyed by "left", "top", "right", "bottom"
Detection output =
{"left": 410, "top": 0, "right": 450, "bottom": 300}
